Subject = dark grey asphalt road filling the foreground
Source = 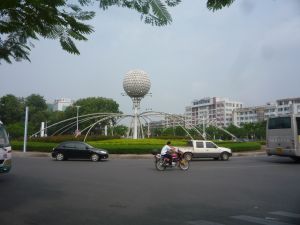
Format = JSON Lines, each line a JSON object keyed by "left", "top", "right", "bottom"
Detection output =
{"left": 0, "top": 156, "right": 300, "bottom": 225}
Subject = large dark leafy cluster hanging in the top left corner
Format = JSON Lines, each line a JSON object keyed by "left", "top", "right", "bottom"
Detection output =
{"left": 0, "top": 0, "right": 95, "bottom": 63}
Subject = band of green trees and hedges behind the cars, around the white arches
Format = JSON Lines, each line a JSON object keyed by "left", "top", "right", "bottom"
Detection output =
{"left": 0, "top": 94, "right": 266, "bottom": 154}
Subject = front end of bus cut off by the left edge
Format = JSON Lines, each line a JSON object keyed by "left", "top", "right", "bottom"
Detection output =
{"left": 0, "top": 121, "right": 12, "bottom": 173}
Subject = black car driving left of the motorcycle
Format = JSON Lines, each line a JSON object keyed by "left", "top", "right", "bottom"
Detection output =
{"left": 52, "top": 141, "right": 108, "bottom": 162}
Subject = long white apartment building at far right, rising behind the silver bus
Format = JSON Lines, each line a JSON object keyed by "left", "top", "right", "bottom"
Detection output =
{"left": 233, "top": 97, "right": 300, "bottom": 126}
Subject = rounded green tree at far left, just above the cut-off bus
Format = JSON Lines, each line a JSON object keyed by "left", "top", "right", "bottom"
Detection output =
{"left": 0, "top": 94, "right": 24, "bottom": 125}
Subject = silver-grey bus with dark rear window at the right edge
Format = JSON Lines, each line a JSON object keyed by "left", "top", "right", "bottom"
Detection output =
{"left": 266, "top": 114, "right": 300, "bottom": 162}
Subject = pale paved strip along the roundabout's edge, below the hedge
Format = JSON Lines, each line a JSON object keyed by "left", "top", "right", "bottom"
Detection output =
{"left": 13, "top": 150, "right": 266, "bottom": 159}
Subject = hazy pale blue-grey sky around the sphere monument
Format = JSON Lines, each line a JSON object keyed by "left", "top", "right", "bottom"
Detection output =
{"left": 0, "top": 0, "right": 300, "bottom": 113}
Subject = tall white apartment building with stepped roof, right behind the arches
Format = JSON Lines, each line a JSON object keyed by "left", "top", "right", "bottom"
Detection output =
{"left": 185, "top": 97, "right": 243, "bottom": 127}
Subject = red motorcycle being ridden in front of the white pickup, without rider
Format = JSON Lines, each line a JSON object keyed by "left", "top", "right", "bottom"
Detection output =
{"left": 154, "top": 150, "right": 190, "bottom": 171}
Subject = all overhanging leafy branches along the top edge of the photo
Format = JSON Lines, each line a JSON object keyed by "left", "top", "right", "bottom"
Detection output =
{"left": 0, "top": 0, "right": 234, "bottom": 63}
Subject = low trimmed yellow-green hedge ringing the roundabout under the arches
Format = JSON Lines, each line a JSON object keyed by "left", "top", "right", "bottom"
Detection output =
{"left": 12, "top": 139, "right": 261, "bottom": 154}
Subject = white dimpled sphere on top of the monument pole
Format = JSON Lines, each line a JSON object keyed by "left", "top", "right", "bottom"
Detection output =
{"left": 123, "top": 70, "right": 151, "bottom": 97}
